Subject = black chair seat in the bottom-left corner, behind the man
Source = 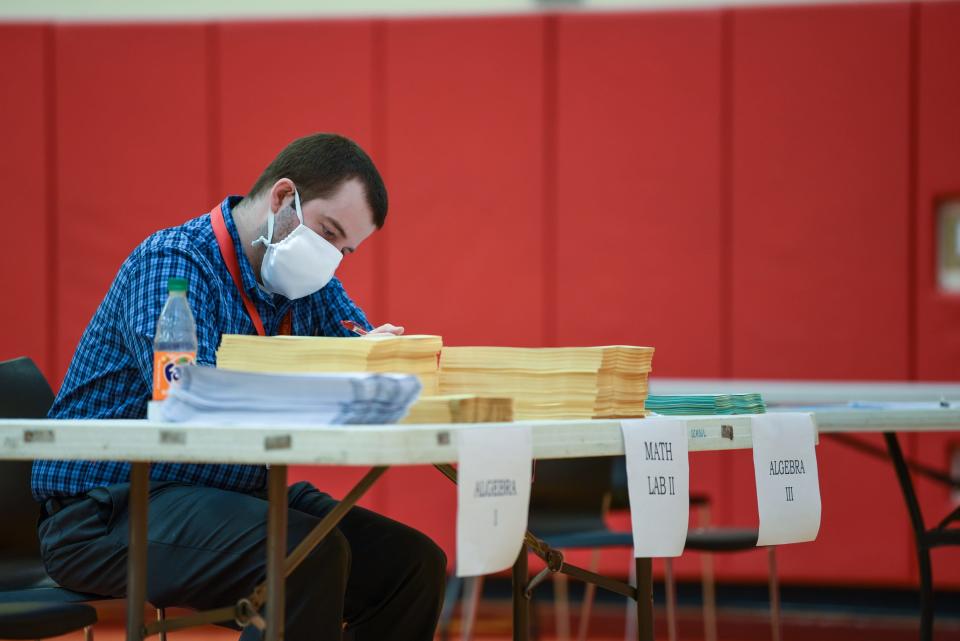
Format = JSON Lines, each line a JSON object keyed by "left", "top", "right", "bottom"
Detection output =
{"left": 0, "top": 603, "right": 97, "bottom": 641}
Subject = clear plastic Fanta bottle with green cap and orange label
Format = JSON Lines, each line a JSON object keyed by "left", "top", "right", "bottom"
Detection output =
{"left": 153, "top": 278, "right": 197, "bottom": 401}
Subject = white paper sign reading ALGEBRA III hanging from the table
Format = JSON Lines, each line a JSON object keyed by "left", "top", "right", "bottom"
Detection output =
{"left": 752, "top": 413, "right": 820, "bottom": 545}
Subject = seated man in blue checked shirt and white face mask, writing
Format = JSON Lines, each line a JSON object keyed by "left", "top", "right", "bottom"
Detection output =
{"left": 33, "top": 134, "right": 446, "bottom": 641}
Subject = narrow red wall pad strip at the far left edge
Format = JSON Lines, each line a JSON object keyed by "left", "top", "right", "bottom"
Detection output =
{"left": 0, "top": 25, "right": 55, "bottom": 377}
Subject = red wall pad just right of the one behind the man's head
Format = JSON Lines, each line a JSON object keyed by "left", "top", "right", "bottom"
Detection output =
{"left": 385, "top": 17, "right": 544, "bottom": 559}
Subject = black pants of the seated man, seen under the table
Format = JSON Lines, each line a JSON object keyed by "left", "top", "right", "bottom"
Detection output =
{"left": 34, "top": 483, "right": 446, "bottom": 641}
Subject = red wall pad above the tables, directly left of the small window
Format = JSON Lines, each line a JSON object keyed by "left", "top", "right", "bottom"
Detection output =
{"left": 730, "top": 5, "right": 909, "bottom": 379}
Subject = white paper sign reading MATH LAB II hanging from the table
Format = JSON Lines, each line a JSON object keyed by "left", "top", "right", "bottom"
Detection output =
{"left": 620, "top": 418, "right": 690, "bottom": 558}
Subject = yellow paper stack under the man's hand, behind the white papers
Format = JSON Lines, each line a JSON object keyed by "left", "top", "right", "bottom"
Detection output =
{"left": 217, "top": 334, "right": 443, "bottom": 395}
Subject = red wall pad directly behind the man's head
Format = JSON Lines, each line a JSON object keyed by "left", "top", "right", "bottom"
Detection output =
{"left": 218, "top": 20, "right": 382, "bottom": 323}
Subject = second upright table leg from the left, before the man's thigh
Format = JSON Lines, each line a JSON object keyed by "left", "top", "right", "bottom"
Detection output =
{"left": 266, "top": 465, "right": 287, "bottom": 641}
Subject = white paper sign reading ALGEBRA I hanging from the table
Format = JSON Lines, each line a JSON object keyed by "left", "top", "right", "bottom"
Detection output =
{"left": 457, "top": 425, "right": 533, "bottom": 576}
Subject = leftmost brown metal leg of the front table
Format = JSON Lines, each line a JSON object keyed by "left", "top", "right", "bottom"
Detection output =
{"left": 127, "top": 463, "right": 150, "bottom": 641}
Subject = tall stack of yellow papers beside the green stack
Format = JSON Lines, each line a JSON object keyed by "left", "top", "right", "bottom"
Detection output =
{"left": 440, "top": 345, "right": 653, "bottom": 420}
